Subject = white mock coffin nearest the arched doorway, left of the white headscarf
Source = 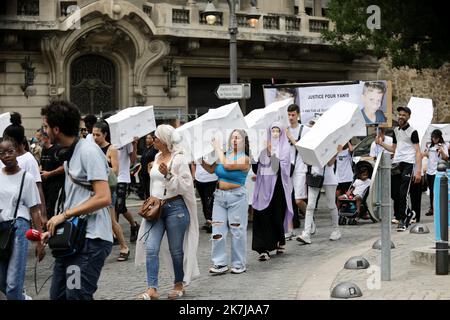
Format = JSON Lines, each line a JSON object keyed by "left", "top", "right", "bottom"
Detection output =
{"left": 106, "top": 106, "right": 156, "bottom": 148}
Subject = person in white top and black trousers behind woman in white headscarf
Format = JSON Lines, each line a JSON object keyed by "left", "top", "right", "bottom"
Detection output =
{"left": 115, "top": 138, "right": 139, "bottom": 243}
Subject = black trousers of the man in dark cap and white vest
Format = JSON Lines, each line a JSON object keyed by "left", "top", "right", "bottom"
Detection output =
{"left": 391, "top": 162, "right": 414, "bottom": 221}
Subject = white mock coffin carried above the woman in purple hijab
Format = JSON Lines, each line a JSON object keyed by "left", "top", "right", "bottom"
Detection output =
{"left": 245, "top": 98, "right": 294, "bottom": 162}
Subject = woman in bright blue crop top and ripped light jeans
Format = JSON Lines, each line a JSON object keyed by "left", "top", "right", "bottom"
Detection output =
{"left": 202, "top": 129, "right": 250, "bottom": 274}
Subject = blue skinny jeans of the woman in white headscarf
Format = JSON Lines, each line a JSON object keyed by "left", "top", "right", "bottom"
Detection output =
{"left": 145, "top": 199, "right": 190, "bottom": 289}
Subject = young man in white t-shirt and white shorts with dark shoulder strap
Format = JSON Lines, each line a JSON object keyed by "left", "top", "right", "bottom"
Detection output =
{"left": 286, "top": 103, "right": 310, "bottom": 232}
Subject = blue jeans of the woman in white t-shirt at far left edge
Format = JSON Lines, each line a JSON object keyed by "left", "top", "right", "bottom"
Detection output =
{"left": 0, "top": 218, "right": 30, "bottom": 300}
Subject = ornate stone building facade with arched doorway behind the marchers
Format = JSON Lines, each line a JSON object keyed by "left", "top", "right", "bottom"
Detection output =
{"left": 0, "top": 0, "right": 379, "bottom": 134}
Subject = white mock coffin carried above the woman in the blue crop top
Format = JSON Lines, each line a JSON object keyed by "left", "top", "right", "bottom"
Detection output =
{"left": 176, "top": 102, "right": 247, "bottom": 162}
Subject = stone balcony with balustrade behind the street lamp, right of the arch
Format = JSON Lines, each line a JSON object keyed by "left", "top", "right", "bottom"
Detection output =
{"left": 149, "top": 2, "right": 333, "bottom": 44}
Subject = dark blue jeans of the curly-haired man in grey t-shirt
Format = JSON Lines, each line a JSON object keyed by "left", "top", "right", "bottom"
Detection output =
{"left": 50, "top": 239, "right": 112, "bottom": 300}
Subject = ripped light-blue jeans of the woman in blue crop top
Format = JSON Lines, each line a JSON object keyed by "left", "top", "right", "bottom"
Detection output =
{"left": 211, "top": 187, "right": 248, "bottom": 268}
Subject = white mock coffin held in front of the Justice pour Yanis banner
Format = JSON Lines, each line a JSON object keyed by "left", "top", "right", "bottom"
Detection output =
{"left": 296, "top": 101, "right": 365, "bottom": 167}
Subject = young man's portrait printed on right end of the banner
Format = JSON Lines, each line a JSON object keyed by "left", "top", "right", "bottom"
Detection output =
{"left": 361, "top": 81, "right": 387, "bottom": 124}
